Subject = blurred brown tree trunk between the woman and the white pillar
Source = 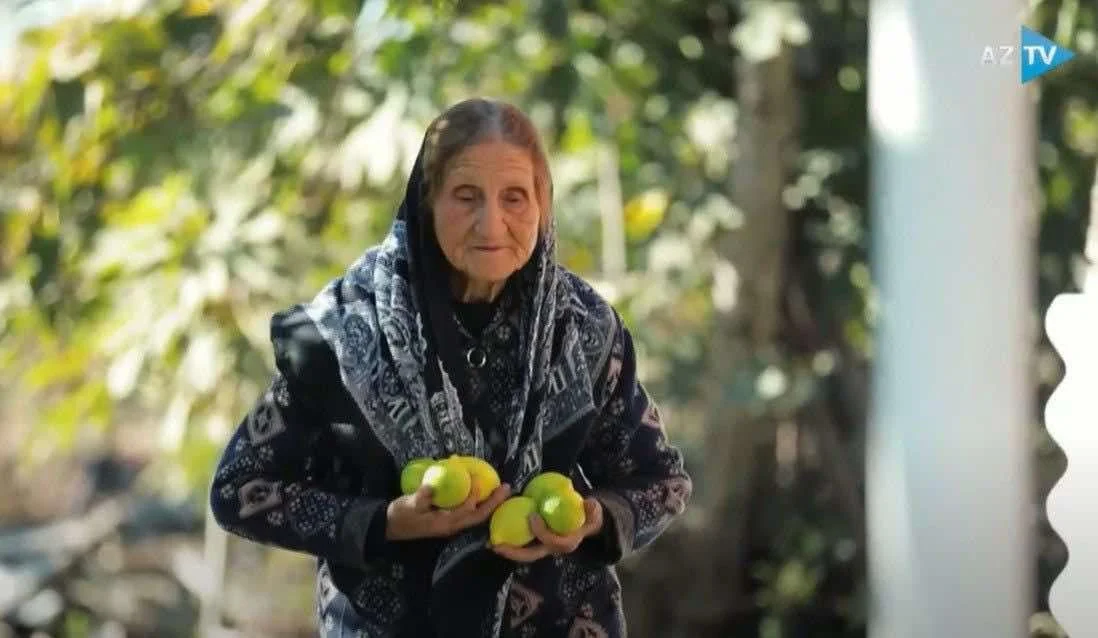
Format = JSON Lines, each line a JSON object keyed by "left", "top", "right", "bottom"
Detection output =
{"left": 681, "top": 47, "right": 798, "bottom": 637}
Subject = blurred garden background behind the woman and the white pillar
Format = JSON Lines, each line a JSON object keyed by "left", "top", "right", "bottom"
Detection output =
{"left": 0, "top": 0, "right": 1098, "bottom": 638}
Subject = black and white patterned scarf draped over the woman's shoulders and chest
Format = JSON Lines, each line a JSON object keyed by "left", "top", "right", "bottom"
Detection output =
{"left": 306, "top": 141, "right": 613, "bottom": 638}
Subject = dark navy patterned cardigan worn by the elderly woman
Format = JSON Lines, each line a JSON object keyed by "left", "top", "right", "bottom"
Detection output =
{"left": 210, "top": 276, "right": 692, "bottom": 638}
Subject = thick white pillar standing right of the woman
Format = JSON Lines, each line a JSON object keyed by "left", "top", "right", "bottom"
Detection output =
{"left": 866, "top": 0, "right": 1037, "bottom": 638}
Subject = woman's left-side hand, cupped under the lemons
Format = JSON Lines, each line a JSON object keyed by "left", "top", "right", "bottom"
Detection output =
{"left": 385, "top": 484, "right": 511, "bottom": 540}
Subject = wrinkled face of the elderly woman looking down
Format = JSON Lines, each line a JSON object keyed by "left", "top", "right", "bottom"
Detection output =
{"left": 433, "top": 142, "right": 542, "bottom": 286}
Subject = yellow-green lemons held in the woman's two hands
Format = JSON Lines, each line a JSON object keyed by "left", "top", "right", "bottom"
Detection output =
{"left": 401, "top": 455, "right": 586, "bottom": 547}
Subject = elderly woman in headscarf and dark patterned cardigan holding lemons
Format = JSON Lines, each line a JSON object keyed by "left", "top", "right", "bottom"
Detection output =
{"left": 210, "top": 99, "right": 692, "bottom": 638}
